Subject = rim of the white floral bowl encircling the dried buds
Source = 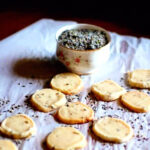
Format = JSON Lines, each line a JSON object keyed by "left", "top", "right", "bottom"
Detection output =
{"left": 55, "top": 23, "right": 111, "bottom": 52}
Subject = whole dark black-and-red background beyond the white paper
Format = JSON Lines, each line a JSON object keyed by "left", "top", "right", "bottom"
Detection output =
{"left": 0, "top": 0, "right": 150, "bottom": 39}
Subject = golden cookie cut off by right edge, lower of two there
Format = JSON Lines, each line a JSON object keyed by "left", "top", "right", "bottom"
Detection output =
{"left": 121, "top": 91, "right": 150, "bottom": 113}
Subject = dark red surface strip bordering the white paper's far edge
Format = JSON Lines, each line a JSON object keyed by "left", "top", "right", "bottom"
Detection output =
{"left": 0, "top": 11, "right": 150, "bottom": 40}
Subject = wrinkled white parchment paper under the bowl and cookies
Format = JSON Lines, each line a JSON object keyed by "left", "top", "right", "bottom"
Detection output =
{"left": 0, "top": 19, "right": 150, "bottom": 150}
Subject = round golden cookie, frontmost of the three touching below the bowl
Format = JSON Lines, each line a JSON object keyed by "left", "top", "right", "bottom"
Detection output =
{"left": 57, "top": 102, "right": 94, "bottom": 124}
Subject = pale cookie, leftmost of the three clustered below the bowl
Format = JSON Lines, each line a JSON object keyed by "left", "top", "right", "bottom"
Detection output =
{"left": 31, "top": 89, "right": 67, "bottom": 112}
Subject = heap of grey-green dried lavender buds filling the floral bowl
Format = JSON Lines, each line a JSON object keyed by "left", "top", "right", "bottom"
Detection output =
{"left": 58, "top": 29, "right": 108, "bottom": 50}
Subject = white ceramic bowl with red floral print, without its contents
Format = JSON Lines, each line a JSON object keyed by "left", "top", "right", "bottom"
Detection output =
{"left": 56, "top": 24, "right": 111, "bottom": 74}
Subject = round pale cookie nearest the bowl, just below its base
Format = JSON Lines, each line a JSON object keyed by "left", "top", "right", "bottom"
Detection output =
{"left": 50, "top": 72, "right": 83, "bottom": 95}
